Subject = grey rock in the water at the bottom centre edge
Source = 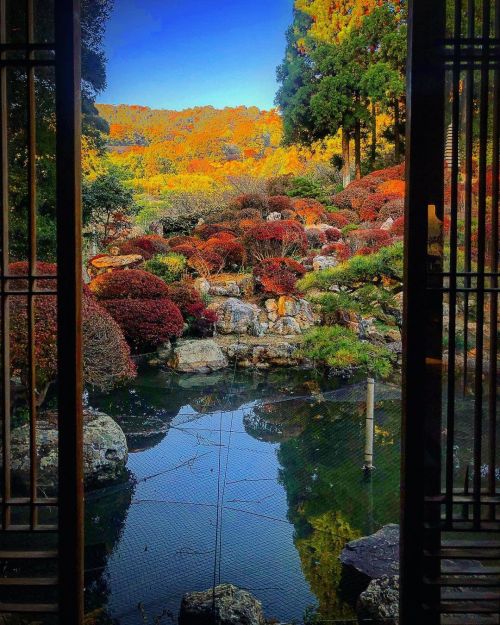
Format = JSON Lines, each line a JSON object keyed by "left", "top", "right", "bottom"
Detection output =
{"left": 179, "top": 584, "right": 265, "bottom": 625}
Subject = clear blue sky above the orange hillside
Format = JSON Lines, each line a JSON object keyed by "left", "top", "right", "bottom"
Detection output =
{"left": 98, "top": 0, "right": 293, "bottom": 110}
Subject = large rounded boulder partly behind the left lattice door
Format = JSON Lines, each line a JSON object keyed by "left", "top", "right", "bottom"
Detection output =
{"left": 3, "top": 410, "right": 128, "bottom": 489}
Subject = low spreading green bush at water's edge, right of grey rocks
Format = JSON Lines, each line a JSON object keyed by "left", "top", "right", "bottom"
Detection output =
{"left": 302, "top": 326, "right": 392, "bottom": 378}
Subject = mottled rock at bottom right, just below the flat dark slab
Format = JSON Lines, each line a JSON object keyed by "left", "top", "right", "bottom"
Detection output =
{"left": 356, "top": 575, "right": 399, "bottom": 625}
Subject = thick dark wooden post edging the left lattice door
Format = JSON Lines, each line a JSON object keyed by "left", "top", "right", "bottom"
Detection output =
{"left": 55, "top": 0, "right": 83, "bottom": 625}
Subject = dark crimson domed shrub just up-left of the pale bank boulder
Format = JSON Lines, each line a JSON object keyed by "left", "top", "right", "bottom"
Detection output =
{"left": 103, "top": 298, "right": 184, "bottom": 353}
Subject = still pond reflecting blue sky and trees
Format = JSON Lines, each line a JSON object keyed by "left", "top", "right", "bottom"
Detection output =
{"left": 86, "top": 369, "right": 400, "bottom": 625}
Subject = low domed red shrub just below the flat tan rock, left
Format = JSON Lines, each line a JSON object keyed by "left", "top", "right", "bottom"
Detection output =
{"left": 89, "top": 269, "right": 168, "bottom": 300}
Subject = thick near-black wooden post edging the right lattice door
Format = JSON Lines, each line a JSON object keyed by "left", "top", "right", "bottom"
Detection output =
{"left": 400, "top": 0, "right": 445, "bottom": 625}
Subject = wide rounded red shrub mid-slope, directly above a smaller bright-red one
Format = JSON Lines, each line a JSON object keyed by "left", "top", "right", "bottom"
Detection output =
{"left": 244, "top": 220, "right": 307, "bottom": 260}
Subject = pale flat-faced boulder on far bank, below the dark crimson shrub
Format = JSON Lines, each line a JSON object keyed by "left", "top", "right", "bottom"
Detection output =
{"left": 168, "top": 339, "right": 229, "bottom": 373}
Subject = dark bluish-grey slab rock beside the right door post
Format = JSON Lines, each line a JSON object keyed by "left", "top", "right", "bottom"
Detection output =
{"left": 340, "top": 524, "right": 399, "bottom": 590}
